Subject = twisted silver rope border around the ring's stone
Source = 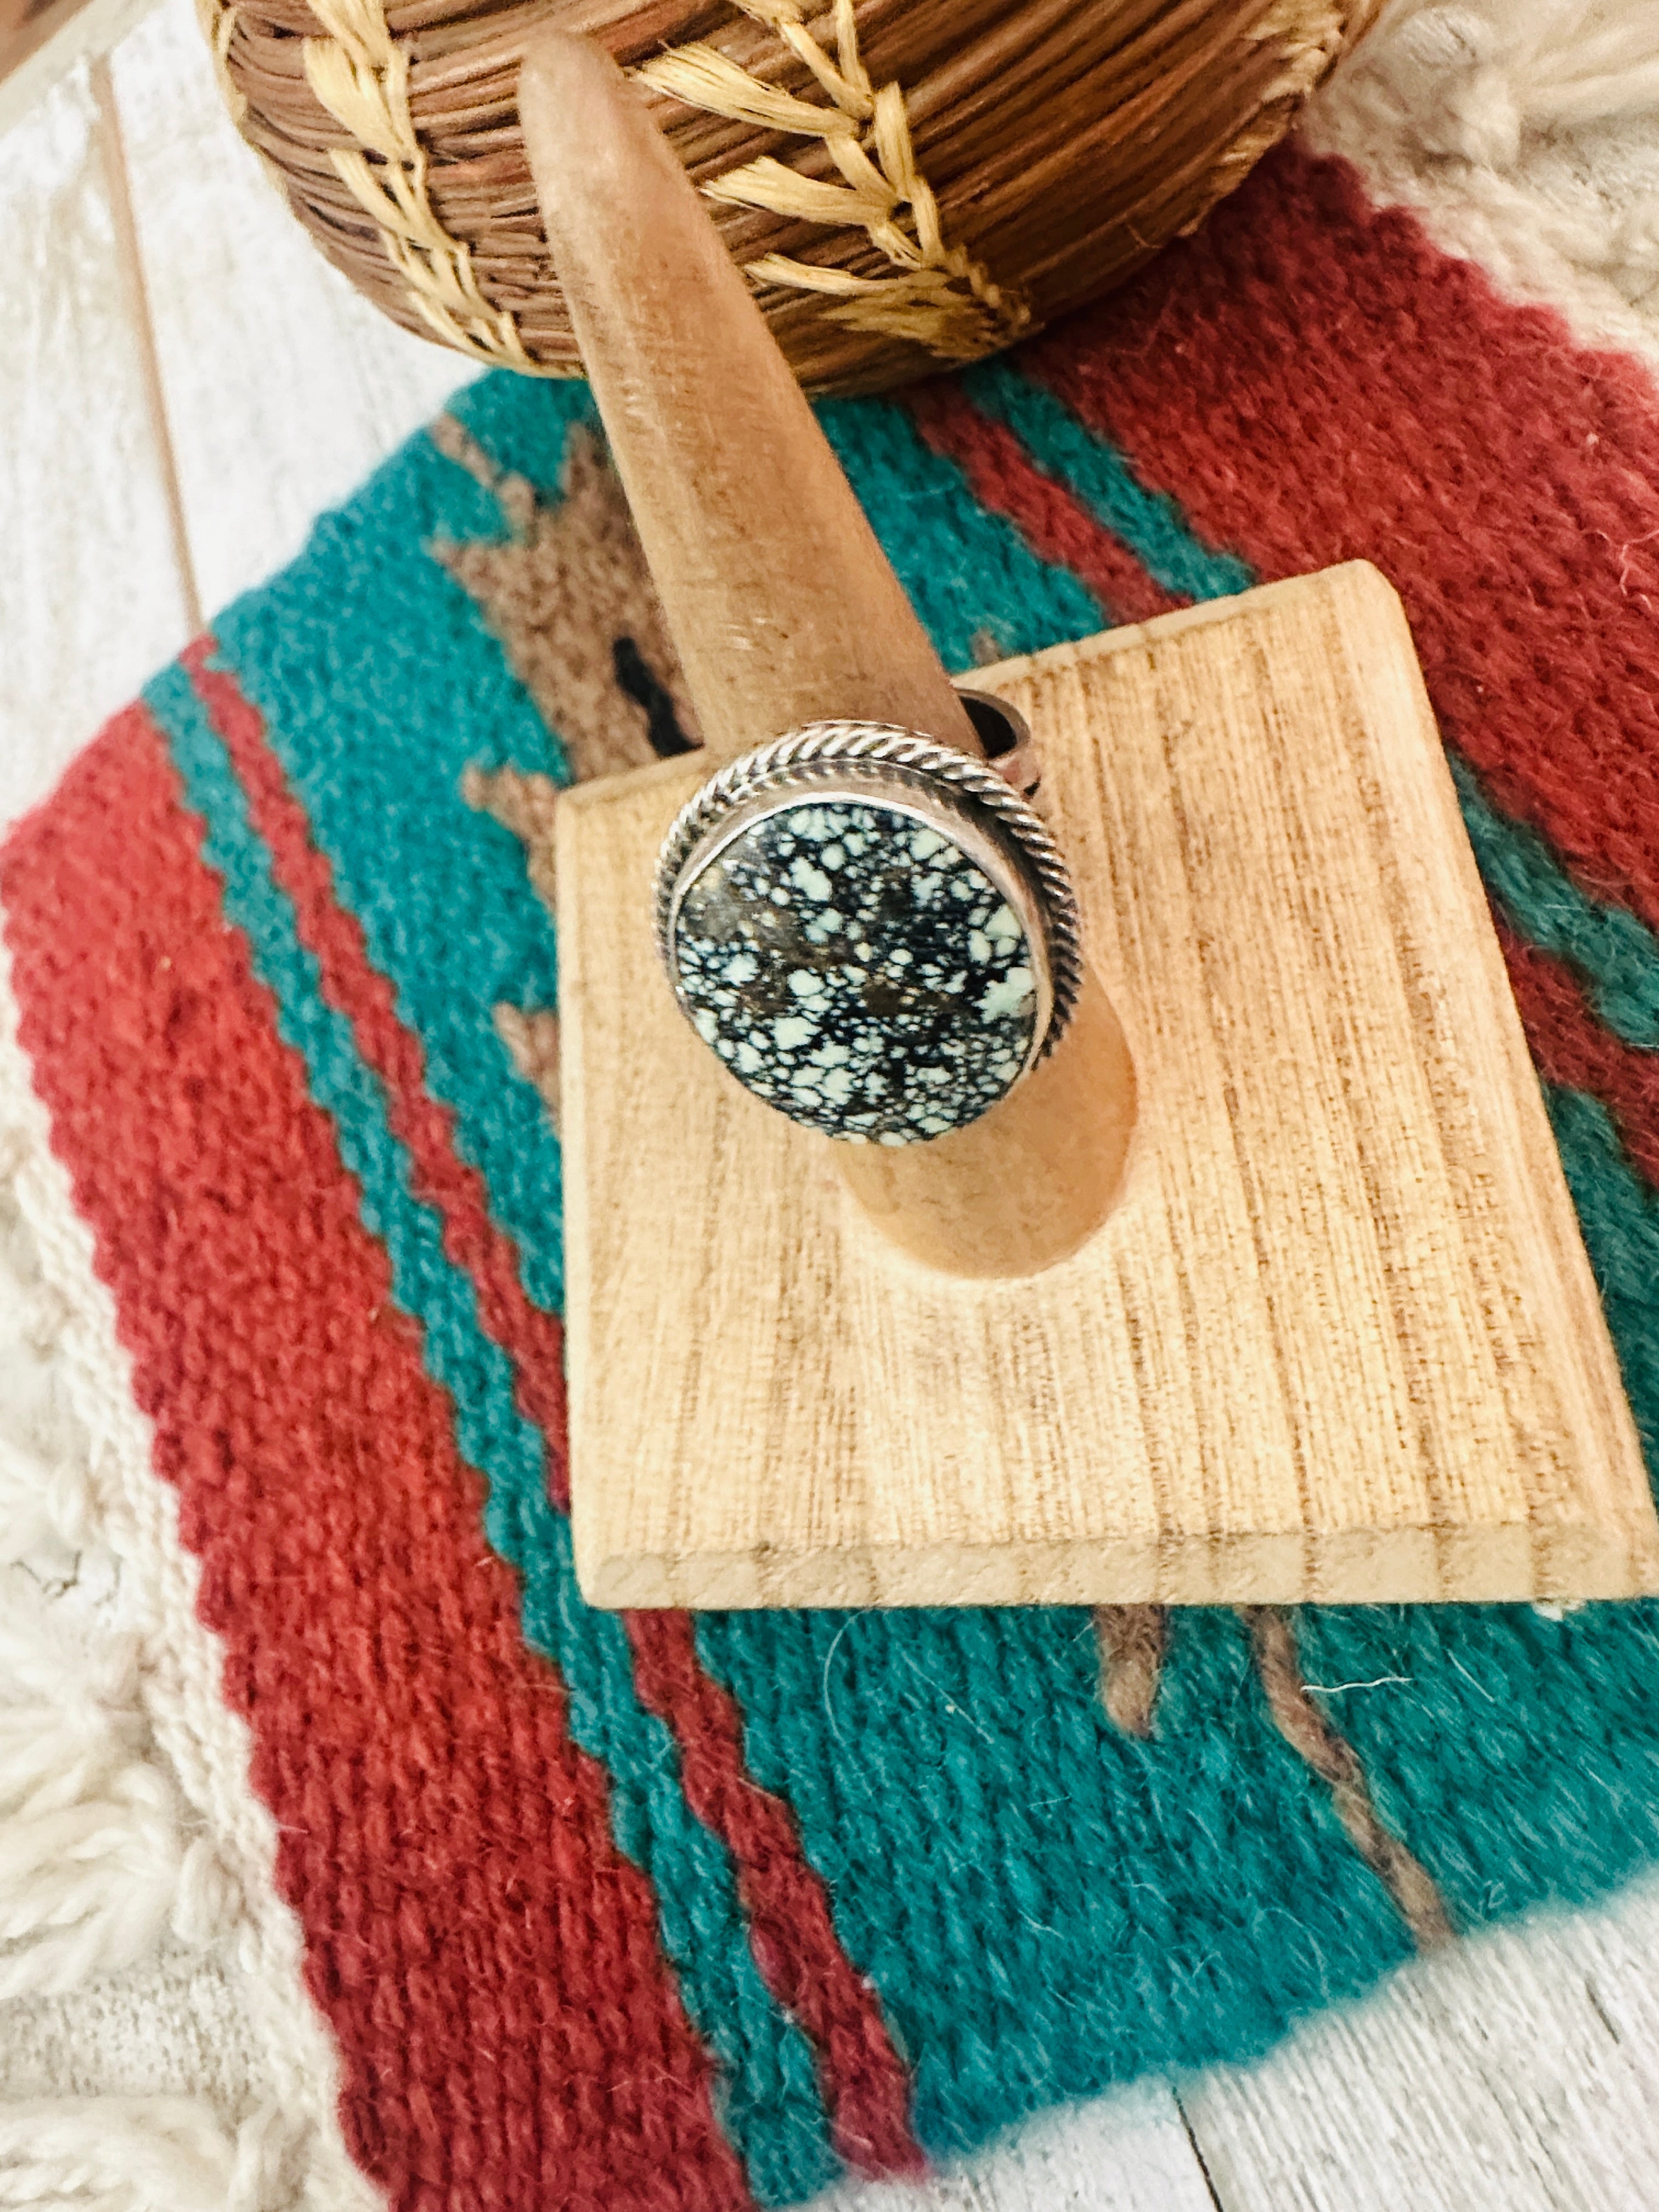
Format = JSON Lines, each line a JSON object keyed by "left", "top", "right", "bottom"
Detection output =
{"left": 652, "top": 721, "right": 1084, "bottom": 1066}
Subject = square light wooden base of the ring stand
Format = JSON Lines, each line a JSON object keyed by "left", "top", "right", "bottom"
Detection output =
{"left": 557, "top": 564, "right": 1659, "bottom": 1606}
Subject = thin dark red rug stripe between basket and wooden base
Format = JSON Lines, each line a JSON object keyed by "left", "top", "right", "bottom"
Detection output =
{"left": 900, "top": 381, "right": 1183, "bottom": 622}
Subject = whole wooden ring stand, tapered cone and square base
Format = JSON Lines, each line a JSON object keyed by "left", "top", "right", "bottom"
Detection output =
{"left": 522, "top": 36, "right": 1659, "bottom": 1606}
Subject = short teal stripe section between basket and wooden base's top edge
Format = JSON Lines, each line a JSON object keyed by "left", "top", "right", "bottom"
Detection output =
{"left": 962, "top": 360, "right": 1256, "bottom": 600}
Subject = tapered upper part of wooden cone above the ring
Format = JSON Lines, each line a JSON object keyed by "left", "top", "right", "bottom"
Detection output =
{"left": 520, "top": 31, "right": 980, "bottom": 768}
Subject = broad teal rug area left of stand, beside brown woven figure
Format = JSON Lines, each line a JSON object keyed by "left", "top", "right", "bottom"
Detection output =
{"left": 215, "top": 411, "right": 579, "bottom": 1312}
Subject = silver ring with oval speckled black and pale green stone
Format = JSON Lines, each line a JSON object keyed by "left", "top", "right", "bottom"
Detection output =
{"left": 654, "top": 721, "right": 1082, "bottom": 1144}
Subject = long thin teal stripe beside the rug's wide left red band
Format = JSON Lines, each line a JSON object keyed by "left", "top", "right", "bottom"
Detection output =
{"left": 146, "top": 646, "right": 840, "bottom": 2203}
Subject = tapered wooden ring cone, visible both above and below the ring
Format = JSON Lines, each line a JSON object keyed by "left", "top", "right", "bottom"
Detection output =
{"left": 520, "top": 31, "right": 1135, "bottom": 1274}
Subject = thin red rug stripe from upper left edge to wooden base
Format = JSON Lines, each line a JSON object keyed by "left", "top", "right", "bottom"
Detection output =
{"left": 182, "top": 637, "right": 571, "bottom": 1511}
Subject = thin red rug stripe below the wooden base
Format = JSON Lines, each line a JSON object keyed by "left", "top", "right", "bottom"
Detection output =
{"left": 626, "top": 1612, "right": 927, "bottom": 2174}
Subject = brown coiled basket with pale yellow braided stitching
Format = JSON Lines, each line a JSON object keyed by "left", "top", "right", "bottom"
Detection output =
{"left": 201, "top": 0, "right": 1376, "bottom": 392}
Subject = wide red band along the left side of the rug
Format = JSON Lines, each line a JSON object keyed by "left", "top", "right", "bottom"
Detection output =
{"left": 0, "top": 708, "right": 748, "bottom": 2212}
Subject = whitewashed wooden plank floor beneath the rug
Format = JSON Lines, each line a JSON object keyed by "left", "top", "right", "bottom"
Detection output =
{"left": 0, "top": 0, "right": 1659, "bottom": 2212}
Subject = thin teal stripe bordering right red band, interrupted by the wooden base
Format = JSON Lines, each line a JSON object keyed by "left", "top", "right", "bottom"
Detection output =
{"left": 982, "top": 360, "right": 1659, "bottom": 1048}
